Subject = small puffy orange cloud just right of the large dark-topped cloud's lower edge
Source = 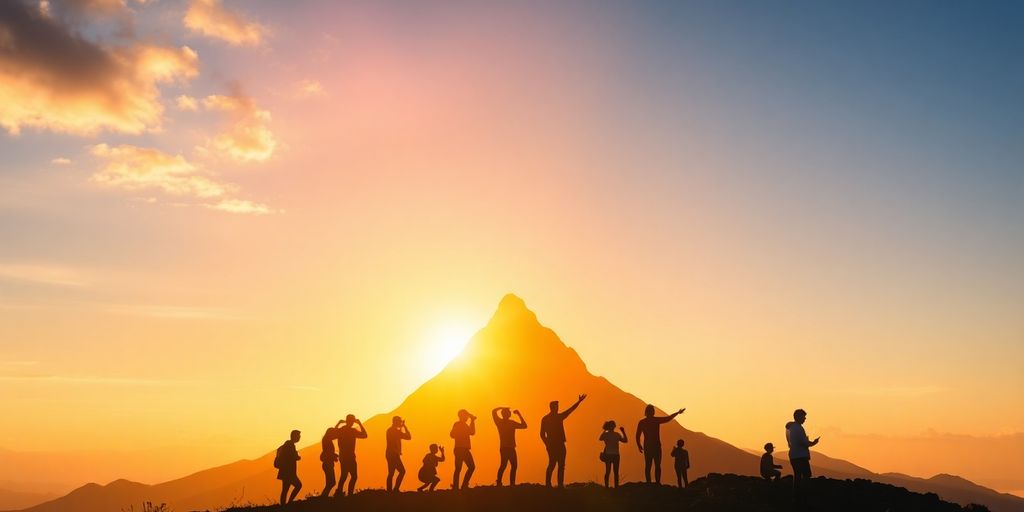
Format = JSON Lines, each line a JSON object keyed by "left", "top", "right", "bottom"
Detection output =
{"left": 203, "top": 88, "right": 278, "bottom": 162}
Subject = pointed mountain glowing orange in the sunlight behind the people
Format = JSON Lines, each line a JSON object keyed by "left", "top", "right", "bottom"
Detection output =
{"left": 14, "top": 295, "right": 1024, "bottom": 512}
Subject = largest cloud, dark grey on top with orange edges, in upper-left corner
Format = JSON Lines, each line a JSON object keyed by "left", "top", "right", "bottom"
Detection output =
{"left": 0, "top": 0, "right": 199, "bottom": 135}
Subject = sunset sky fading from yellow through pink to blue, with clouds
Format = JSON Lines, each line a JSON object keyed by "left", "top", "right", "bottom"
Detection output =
{"left": 0, "top": 0, "right": 1024, "bottom": 494}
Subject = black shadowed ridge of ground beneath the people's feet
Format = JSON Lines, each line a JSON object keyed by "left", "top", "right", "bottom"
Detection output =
{"left": 222, "top": 474, "right": 987, "bottom": 512}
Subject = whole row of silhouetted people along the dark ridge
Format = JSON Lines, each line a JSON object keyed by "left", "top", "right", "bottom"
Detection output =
{"left": 273, "top": 401, "right": 819, "bottom": 505}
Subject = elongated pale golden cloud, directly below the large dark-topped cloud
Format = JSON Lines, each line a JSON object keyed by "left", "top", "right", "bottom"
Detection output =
{"left": 92, "top": 144, "right": 229, "bottom": 199}
